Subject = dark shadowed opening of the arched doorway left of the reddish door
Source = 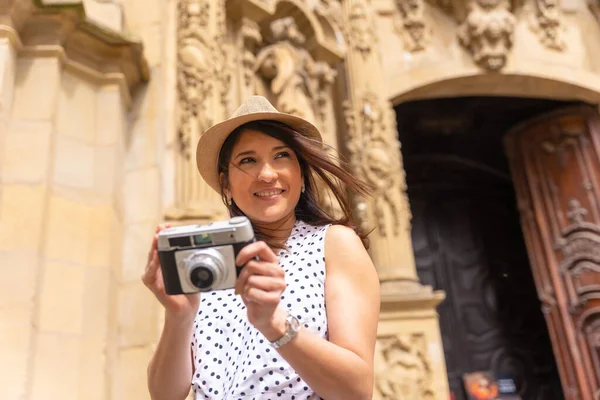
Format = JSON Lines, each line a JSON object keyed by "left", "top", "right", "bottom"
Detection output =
{"left": 396, "top": 97, "right": 580, "bottom": 400}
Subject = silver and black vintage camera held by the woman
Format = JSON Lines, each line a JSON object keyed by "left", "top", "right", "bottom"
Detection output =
{"left": 158, "top": 217, "right": 256, "bottom": 295}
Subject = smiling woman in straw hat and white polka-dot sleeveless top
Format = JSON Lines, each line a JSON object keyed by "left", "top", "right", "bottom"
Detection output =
{"left": 142, "top": 96, "right": 379, "bottom": 400}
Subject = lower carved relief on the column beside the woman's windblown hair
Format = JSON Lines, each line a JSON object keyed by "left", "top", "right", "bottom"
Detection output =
{"left": 345, "top": 93, "right": 406, "bottom": 236}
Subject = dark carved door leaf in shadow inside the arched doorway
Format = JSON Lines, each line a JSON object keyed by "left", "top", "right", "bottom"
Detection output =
{"left": 405, "top": 156, "right": 563, "bottom": 400}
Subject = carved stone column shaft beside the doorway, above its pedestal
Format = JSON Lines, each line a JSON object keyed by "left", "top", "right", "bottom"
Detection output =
{"left": 343, "top": 0, "right": 417, "bottom": 287}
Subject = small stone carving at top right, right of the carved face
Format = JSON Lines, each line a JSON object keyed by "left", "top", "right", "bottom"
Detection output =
{"left": 529, "top": 0, "right": 566, "bottom": 50}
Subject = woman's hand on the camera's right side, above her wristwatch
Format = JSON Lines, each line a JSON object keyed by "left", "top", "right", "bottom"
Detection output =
{"left": 235, "top": 242, "right": 286, "bottom": 341}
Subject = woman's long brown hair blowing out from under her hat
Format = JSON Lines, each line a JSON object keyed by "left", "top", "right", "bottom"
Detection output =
{"left": 218, "top": 121, "right": 370, "bottom": 249}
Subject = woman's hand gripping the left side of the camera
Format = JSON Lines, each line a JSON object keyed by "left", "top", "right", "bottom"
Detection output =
{"left": 142, "top": 224, "right": 200, "bottom": 318}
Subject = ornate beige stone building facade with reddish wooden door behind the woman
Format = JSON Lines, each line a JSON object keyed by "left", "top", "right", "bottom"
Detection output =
{"left": 0, "top": 0, "right": 600, "bottom": 400}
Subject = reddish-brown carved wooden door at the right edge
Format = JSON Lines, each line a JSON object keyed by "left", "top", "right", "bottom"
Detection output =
{"left": 505, "top": 107, "right": 600, "bottom": 400}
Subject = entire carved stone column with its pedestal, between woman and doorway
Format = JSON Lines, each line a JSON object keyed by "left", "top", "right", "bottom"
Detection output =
{"left": 342, "top": 0, "right": 448, "bottom": 400}
